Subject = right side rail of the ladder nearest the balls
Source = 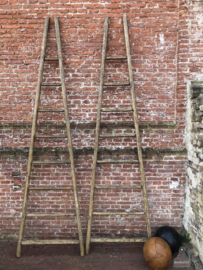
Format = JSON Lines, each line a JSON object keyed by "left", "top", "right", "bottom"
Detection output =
{"left": 123, "top": 14, "right": 151, "bottom": 238}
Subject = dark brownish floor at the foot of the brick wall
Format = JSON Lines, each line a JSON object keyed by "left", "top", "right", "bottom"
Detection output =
{"left": 0, "top": 243, "right": 193, "bottom": 270}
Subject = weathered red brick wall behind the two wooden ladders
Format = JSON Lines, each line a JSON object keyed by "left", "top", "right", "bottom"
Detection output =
{"left": 0, "top": 0, "right": 202, "bottom": 240}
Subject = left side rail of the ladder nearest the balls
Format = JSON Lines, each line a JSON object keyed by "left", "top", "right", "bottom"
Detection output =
{"left": 86, "top": 16, "right": 109, "bottom": 254}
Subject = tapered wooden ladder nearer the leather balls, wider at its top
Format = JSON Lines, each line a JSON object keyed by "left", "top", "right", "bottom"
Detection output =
{"left": 86, "top": 14, "right": 151, "bottom": 254}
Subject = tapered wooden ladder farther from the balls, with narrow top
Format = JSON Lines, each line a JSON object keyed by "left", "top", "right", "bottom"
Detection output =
{"left": 16, "top": 17, "right": 84, "bottom": 257}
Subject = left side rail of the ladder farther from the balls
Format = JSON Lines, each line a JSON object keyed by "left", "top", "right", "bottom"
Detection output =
{"left": 16, "top": 17, "right": 49, "bottom": 257}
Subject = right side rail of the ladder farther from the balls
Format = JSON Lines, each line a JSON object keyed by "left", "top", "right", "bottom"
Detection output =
{"left": 54, "top": 17, "right": 84, "bottom": 256}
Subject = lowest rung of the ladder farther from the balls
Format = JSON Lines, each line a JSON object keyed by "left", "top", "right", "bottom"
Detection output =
{"left": 22, "top": 239, "right": 79, "bottom": 245}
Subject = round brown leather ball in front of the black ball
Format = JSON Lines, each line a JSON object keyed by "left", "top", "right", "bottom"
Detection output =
{"left": 143, "top": 237, "right": 172, "bottom": 270}
